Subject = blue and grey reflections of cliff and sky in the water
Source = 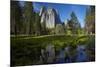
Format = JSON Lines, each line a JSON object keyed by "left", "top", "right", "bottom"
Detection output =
{"left": 40, "top": 44, "right": 87, "bottom": 63}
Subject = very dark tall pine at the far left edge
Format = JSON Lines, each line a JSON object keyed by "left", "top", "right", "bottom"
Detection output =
{"left": 10, "top": 1, "right": 22, "bottom": 35}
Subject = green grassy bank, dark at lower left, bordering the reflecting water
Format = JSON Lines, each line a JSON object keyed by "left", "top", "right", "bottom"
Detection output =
{"left": 11, "top": 35, "right": 95, "bottom": 66}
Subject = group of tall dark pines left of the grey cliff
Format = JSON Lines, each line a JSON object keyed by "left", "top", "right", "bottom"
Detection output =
{"left": 10, "top": 1, "right": 41, "bottom": 35}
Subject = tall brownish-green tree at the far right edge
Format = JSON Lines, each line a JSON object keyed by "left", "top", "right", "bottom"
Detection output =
{"left": 85, "top": 6, "right": 95, "bottom": 34}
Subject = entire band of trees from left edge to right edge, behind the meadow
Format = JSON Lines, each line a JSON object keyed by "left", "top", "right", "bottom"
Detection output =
{"left": 10, "top": 1, "right": 95, "bottom": 35}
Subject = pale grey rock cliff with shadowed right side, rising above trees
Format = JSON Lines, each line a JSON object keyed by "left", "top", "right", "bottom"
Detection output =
{"left": 39, "top": 7, "right": 61, "bottom": 28}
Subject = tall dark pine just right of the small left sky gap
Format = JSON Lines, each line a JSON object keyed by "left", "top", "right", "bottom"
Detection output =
{"left": 23, "top": 2, "right": 34, "bottom": 35}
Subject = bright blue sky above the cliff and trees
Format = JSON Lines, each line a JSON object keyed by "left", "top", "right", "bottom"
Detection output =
{"left": 21, "top": 2, "right": 89, "bottom": 27}
